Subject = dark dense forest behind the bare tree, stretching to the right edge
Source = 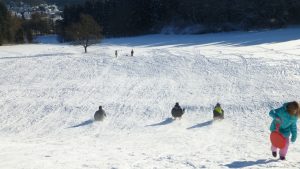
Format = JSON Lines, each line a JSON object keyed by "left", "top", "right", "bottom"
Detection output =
{"left": 62, "top": 0, "right": 300, "bottom": 36}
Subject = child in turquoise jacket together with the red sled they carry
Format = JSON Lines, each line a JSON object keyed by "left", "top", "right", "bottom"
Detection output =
{"left": 269, "top": 101, "right": 300, "bottom": 160}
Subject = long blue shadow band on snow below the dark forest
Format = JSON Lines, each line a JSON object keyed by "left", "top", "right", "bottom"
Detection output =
{"left": 104, "top": 28, "right": 300, "bottom": 47}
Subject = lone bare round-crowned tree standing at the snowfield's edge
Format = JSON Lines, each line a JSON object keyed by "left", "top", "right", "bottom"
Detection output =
{"left": 67, "top": 14, "right": 103, "bottom": 53}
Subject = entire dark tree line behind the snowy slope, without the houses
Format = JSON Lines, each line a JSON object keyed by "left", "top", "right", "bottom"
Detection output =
{"left": 0, "top": 0, "right": 300, "bottom": 43}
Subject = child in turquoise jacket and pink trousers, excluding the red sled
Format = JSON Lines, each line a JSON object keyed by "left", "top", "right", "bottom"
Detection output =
{"left": 269, "top": 101, "right": 300, "bottom": 160}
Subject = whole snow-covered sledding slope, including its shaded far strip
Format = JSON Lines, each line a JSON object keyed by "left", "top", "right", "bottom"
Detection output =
{"left": 0, "top": 28, "right": 300, "bottom": 169}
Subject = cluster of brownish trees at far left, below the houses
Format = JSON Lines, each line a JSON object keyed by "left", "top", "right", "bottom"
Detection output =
{"left": 0, "top": 1, "right": 55, "bottom": 45}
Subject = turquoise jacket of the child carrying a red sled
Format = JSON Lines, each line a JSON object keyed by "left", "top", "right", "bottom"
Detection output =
{"left": 269, "top": 104, "right": 298, "bottom": 142}
